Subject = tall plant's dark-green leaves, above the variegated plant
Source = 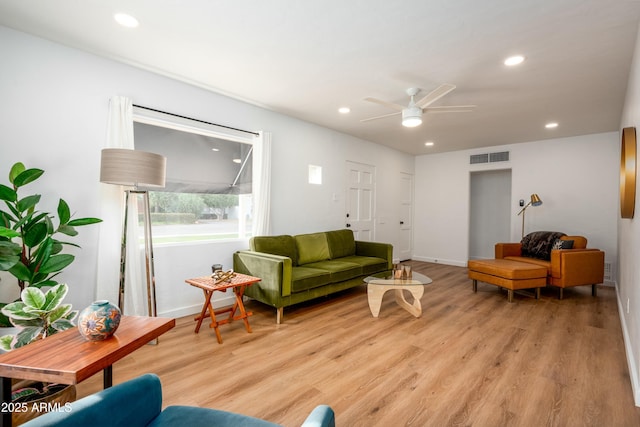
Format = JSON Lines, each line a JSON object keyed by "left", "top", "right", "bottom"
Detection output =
{"left": 0, "top": 163, "right": 102, "bottom": 326}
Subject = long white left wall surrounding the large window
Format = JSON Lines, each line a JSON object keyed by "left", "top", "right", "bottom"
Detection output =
{"left": 0, "top": 26, "right": 414, "bottom": 315}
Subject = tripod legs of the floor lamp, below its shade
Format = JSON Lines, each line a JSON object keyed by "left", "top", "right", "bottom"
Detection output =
{"left": 118, "top": 190, "right": 158, "bottom": 317}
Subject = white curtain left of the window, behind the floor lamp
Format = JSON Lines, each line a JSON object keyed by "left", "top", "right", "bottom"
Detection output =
{"left": 96, "top": 96, "right": 148, "bottom": 315}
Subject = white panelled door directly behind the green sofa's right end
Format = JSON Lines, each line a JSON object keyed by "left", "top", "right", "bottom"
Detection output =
{"left": 345, "top": 161, "right": 376, "bottom": 241}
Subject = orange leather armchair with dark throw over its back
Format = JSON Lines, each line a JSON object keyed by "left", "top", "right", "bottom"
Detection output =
{"left": 495, "top": 236, "right": 604, "bottom": 299}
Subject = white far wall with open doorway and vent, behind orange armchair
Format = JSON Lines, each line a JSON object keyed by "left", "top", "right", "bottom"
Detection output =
{"left": 414, "top": 132, "right": 619, "bottom": 266}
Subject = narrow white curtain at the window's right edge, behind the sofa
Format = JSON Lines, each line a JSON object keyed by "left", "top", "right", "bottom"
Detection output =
{"left": 252, "top": 132, "right": 271, "bottom": 236}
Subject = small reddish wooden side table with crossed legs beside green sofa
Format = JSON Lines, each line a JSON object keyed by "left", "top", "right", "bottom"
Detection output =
{"left": 185, "top": 273, "right": 261, "bottom": 344}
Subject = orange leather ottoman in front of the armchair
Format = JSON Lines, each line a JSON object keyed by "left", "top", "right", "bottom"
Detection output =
{"left": 467, "top": 259, "right": 547, "bottom": 302}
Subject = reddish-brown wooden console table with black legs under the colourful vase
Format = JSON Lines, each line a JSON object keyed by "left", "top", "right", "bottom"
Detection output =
{"left": 0, "top": 316, "right": 176, "bottom": 426}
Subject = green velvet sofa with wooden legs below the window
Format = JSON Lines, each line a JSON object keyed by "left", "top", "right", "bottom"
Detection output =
{"left": 233, "top": 229, "right": 393, "bottom": 323}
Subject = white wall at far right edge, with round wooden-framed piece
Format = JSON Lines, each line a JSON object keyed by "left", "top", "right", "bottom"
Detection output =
{"left": 617, "top": 16, "right": 640, "bottom": 406}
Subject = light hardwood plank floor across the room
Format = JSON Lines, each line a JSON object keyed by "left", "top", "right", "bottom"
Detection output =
{"left": 78, "top": 262, "right": 640, "bottom": 426}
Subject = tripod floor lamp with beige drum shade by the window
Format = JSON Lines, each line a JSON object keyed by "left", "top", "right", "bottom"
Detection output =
{"left": 100, "top": 148, "right": 167, "bottom": 317}
